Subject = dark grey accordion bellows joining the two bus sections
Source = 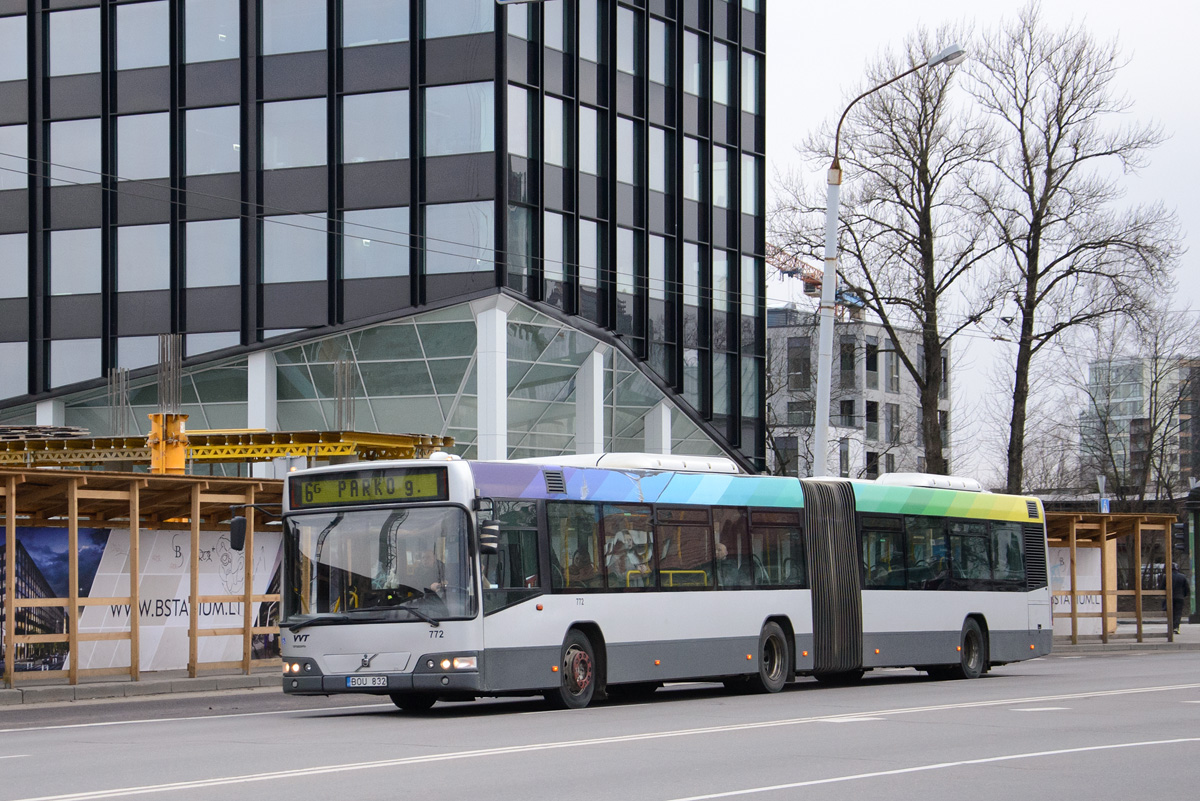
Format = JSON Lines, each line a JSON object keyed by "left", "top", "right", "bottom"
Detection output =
{"left": 800, "top": 480, "right": 863, "bottom": 673}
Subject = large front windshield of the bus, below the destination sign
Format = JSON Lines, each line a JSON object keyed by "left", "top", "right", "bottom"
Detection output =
{"left": 283, "top": 506, "right": 476, "bottom": 621}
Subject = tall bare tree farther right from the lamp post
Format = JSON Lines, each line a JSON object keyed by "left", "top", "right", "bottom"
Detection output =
{"left": 971, "top": 1, "right": 1181, "bottom": 493}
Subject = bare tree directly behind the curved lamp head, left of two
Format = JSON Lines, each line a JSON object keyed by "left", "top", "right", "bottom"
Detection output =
{"left": 770, "top": 28, "right": 995, "bottom": 474}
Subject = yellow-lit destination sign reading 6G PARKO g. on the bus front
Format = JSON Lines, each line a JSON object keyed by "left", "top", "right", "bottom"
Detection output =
{"left": 288, "top": 468, "right": 448, "bottom": 508}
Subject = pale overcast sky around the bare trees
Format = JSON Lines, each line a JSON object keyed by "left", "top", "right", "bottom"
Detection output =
{"left": 767, "top": 0, "right": 1200, "bottom": 480}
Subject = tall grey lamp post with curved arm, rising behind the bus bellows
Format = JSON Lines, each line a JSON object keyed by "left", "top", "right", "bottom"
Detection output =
{"left": 812, "top": 44, "right": 967, "bottom": 476}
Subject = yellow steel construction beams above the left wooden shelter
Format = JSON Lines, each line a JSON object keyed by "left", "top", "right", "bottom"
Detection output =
{"left": 0, "top": 431, "right": 454, "bottom": 475}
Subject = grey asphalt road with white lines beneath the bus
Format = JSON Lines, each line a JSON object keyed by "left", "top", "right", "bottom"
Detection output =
{"left": 0, "top": 651, "right": 1200, "bottom": 801}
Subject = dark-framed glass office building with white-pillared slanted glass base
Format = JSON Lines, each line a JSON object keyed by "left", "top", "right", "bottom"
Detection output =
{"left": 0, "top": 0, "right": 766, "bottom": 469}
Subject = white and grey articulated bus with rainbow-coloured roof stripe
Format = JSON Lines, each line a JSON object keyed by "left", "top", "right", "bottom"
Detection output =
{"left": 253, "top": 453, "right": 1051, "bottom": 711}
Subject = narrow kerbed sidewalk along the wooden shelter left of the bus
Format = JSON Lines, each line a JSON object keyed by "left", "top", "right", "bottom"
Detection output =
{"left": 0, "top": 670, "right": 282, "bottom": 709}
